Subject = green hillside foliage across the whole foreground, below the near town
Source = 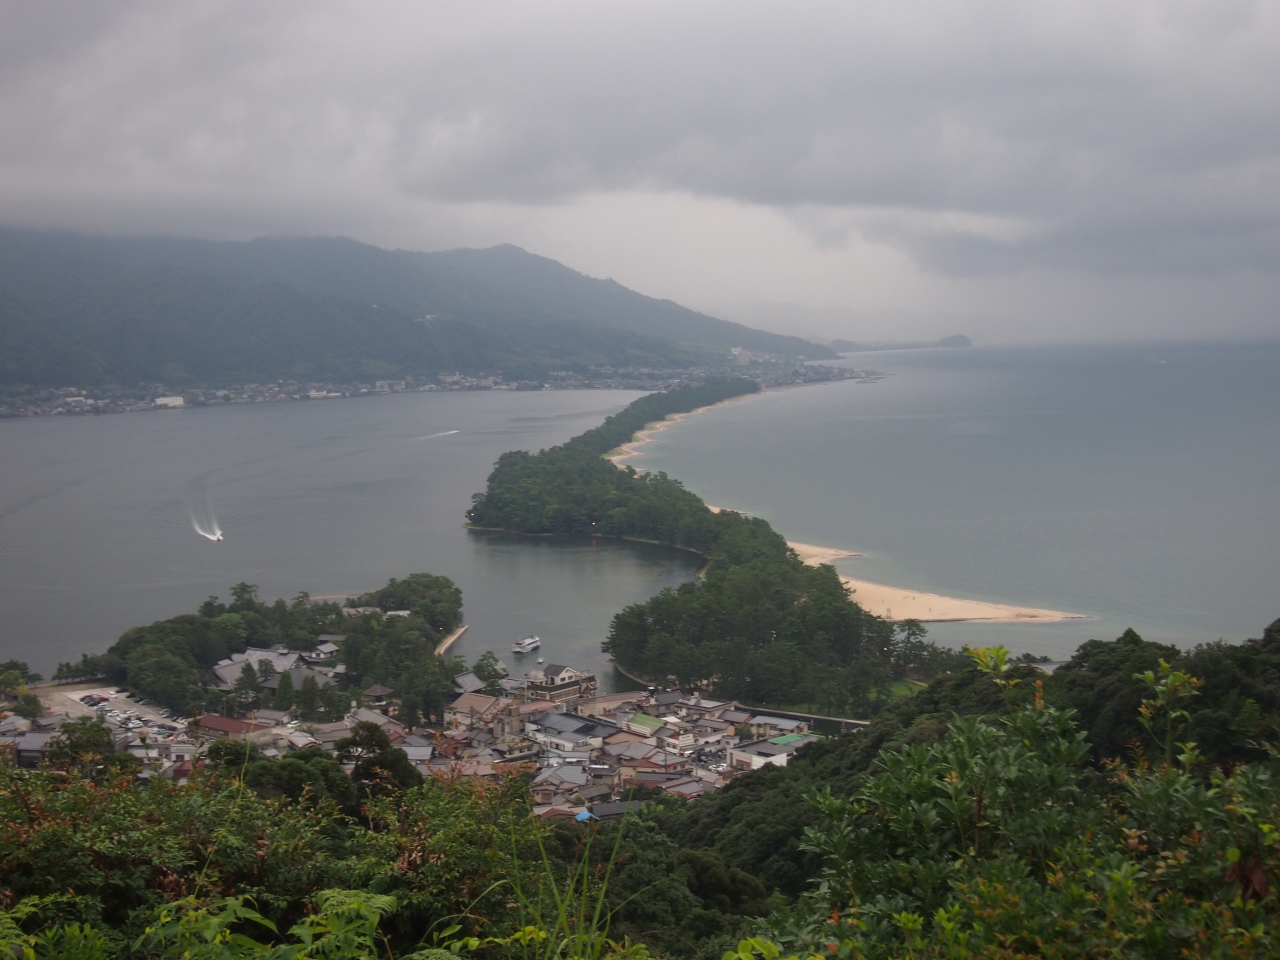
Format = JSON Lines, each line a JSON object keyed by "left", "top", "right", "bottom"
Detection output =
{"left": 0, "top": 622, "right": 1280, "bottom": 960}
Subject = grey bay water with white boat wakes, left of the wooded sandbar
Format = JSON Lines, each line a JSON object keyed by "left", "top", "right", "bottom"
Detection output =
{"left": 0, "top": 390, "right": 698, "bottom": 686}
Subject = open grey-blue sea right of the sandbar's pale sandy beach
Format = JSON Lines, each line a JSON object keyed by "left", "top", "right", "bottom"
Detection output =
{"left": 632, "top": 344, "right": 1280, "bottom": 657}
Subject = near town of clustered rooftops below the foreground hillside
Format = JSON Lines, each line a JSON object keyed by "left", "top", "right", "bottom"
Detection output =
{"left": 0, "top": 635, "right": 818, "bottom": 819}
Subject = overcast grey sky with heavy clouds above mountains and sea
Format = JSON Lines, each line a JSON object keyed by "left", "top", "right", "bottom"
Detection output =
{"left": 0, "top": 0, "right": 1280, "bottom": 340}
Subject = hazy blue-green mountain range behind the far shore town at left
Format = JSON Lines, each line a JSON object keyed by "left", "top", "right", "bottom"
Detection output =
{"left": 0, "top": 229, "right": 837, "bottom": 387}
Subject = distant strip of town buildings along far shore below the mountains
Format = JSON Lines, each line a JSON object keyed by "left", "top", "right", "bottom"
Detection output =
{"left": 0, "top": 358, "right": 883, "bottom": 419}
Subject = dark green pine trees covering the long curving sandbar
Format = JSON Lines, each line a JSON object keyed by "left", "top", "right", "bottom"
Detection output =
{"left": 467, "top": 380, "right": 954, "bottom": 716}
